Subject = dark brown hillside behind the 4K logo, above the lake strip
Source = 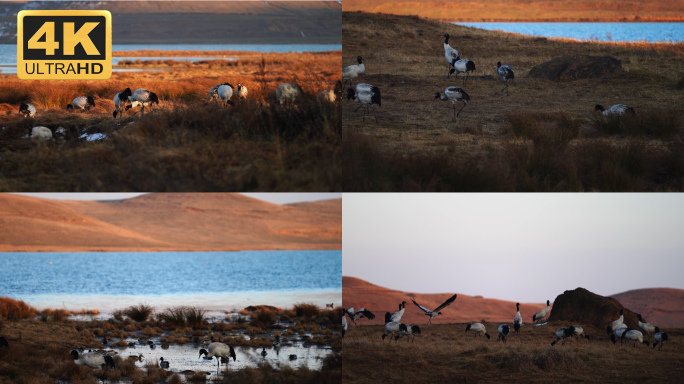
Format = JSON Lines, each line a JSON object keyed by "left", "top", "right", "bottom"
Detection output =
{"left": 0, "top": 1, "right": 342, "bottom": 44}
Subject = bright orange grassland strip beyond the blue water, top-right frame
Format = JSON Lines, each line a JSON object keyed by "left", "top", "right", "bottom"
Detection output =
{"left": 342, "top": 0, "right": 684, "bottom": 22}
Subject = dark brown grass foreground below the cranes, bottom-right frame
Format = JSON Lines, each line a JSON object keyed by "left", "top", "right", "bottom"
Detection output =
{"left": 342, "top": 319, "right": 684, "bottom": 383}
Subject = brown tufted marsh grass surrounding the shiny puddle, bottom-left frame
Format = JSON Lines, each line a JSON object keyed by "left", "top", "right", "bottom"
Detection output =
{"left": 0, "top": 298, "right": 342, "bottom": 383}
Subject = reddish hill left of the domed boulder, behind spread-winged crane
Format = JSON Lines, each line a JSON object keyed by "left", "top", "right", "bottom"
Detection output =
{"left": 342, "top": 276, "right": 545, "bottom": 325}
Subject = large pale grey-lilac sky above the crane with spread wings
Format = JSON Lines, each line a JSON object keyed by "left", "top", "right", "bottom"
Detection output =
{"left": 342, "top": 193, "right": 684, "bottom": 303}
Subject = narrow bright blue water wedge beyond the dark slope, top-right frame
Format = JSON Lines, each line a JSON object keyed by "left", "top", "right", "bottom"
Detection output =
{"left": 454, "top": 22, "right": 684, "bottom": 43}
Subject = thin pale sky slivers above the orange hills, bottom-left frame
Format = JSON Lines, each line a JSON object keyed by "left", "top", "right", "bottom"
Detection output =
{"left": 12, "top": 193, "right": 342, "bottom": 204}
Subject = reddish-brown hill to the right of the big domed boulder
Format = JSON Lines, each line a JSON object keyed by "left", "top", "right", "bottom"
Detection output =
{"left": 611, "top": 288, "right": 684, "bottom": 328}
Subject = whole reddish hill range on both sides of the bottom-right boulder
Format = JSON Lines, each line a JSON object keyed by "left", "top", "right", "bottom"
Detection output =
{"left": 342, "top": 276, "right": 684, "bottom": 328}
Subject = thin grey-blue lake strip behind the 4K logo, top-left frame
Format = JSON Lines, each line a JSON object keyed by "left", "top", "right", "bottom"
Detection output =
{"left": 0, "top": 44, "right": 342, "bottom": 74}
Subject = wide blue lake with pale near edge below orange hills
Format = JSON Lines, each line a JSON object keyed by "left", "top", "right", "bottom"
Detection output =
{"left": 0, "top": 251, "right": 342, "bottom": 314}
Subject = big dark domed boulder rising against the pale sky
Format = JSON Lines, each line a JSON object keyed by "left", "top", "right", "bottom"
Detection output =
{"left": 549, "top": 288, "right": 639, "bottom": 329}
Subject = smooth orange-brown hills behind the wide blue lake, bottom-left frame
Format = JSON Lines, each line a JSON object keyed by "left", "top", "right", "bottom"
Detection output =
{"left": 0, "top": 193, "right": 342, "bottom": 252}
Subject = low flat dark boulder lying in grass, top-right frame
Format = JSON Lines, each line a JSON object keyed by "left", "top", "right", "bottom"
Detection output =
{"left": 530, "top": 55, "right": 622, "bottom": 81}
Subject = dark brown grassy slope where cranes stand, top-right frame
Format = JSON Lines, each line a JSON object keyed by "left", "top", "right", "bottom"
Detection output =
{"left": 342, "top": 12, "right": 684, "bottom": 192}
